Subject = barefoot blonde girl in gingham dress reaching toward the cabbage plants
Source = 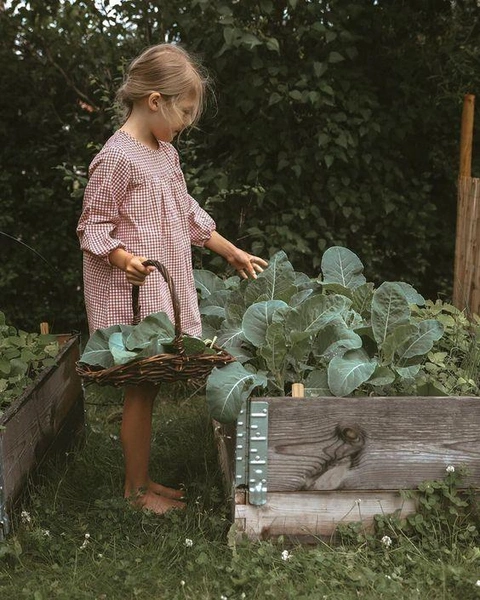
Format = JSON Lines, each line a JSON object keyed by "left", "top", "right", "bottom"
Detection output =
{"left": 77, "top": 44, "right": 267, "bottom": 514}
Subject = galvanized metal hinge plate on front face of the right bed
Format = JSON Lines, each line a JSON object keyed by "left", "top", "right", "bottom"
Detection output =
{"left": 248, "top": 400, "right": 268, "bottom": 506}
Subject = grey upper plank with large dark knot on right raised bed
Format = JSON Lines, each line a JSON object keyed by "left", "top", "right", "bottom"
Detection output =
{"left": 267, "top": 397, "right": 480, "bottom": 492}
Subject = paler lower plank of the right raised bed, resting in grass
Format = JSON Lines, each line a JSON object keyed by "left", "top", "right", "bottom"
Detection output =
{"left": 235, "top": 490, "right": 417, "bottom": 542}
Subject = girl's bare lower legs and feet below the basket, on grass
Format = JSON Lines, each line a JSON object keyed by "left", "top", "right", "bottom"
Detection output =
{"left": 121, "top": 384, "right": 185, "bottom": 513}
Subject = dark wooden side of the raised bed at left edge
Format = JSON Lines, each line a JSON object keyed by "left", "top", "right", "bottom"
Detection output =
{"left": 0, "top": 335, "right": 84, "bottom": 539}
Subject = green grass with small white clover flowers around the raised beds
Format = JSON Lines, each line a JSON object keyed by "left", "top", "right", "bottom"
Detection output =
{"left": 0, "top": 390, "right": 480, "bottom": 600}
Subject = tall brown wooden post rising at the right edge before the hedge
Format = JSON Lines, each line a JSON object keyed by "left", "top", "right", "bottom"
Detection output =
{"left": 453, "top": 94, "right": 477, "bottom": 310}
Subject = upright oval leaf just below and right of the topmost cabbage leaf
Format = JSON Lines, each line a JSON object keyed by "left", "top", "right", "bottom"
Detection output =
{"left": 372, "top": 281, "right": 410, "bottom": 348}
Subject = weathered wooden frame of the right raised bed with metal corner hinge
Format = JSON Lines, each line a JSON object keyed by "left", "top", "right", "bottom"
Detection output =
{"left": 217, "top": 397, "right": 480, "bottom": 541}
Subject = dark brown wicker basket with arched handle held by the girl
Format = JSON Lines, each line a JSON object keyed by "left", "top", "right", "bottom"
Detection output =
{"left": 77, "top": 260, "right": 235, "bottom": 387}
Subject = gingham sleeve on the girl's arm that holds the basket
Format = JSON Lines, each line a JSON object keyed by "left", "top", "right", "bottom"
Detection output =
{"left": 77, "top": 147, "right": 131, "bottom": 262}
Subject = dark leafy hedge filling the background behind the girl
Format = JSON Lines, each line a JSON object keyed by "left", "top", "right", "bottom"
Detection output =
{"left": 0, "top": 0, "right": 480, "bottom": 331}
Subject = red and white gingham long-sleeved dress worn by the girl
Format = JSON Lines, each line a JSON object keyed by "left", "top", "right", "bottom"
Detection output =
{"left": 77, "top": 131, "right": 215, "bottom": 335}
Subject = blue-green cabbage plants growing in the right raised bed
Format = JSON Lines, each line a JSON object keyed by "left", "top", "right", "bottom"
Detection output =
{"left": 195, "top": 247, "right": 479, "bottom": 422}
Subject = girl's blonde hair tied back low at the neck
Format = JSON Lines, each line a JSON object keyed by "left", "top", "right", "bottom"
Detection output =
{"left": 117, "top": 44, "right": 209, "bottom": 125}
